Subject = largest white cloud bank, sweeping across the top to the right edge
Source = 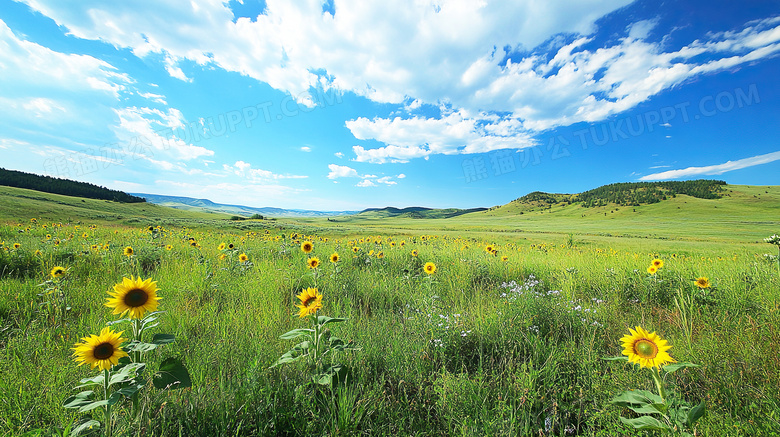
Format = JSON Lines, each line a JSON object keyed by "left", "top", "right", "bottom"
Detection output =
{"left": 15, "top": 0, "right": 780, "bottom": 163}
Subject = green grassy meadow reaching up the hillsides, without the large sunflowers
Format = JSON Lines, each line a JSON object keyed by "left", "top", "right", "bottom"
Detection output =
{"left": 0, "top": 186, "right": 780, "bottom": 436}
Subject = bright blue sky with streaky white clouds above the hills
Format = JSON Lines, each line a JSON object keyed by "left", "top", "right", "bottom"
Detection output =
{"left": 0, "top": 0, "right": 780, "bottom": 210}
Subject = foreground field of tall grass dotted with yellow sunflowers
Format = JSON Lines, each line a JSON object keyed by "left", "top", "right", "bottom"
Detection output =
{"left": 0, "top": 217, "right": 780, "bottom": 436}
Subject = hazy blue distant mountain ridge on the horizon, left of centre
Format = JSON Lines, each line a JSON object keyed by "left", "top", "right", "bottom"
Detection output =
{"left": 133, "top": 193, "right": 358, "bottom": 217}
